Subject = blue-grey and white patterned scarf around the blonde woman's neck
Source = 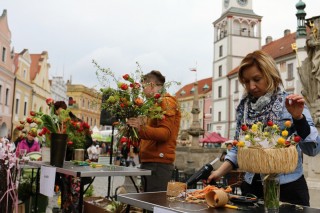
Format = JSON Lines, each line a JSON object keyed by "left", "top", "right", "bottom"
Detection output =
{"left": 235, "top": 88, "right": 286, "bottom": 140}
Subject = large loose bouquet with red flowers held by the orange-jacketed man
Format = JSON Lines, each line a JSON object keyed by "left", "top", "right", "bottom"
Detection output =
{"left": 93, "top": 61, "right": 171, "bottom": 146}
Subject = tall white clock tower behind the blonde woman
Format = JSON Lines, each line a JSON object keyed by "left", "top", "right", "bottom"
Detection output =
{"left": 211, "top": 0, "right": 262, "bottom": 138}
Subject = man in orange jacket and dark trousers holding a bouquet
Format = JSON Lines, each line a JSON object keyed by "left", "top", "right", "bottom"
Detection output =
{"left": 127, "top": 70, "right": 181, "bottom": 192}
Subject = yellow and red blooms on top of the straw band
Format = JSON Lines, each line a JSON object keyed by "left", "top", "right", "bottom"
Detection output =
{"left": 234, "top": 121, "right": 301, "bottom": 148}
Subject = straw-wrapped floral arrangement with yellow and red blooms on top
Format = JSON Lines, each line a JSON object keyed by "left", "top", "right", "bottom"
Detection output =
{"left": 235, "top": 121, "right": 301, "bottom": 174}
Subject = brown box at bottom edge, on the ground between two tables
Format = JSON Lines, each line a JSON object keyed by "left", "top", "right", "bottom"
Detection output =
{"left": 83, "top": 197, "right": 111, "bottom": 213}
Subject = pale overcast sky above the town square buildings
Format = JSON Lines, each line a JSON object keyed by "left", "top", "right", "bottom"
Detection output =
{"left": 0, "top": 0, "right": 320, "bottom": 92}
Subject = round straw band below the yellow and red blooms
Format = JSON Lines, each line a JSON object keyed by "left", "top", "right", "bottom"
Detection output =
{"left": 238, "top": 146, "right": 298, "bottom": 174}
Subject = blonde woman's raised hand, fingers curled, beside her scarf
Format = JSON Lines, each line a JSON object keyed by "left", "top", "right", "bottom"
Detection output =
{"left": 285, "top": 94, "right": 305, "bottom": 120}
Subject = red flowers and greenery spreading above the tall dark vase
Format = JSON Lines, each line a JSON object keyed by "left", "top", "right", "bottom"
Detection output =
{"left": 16, "top": 98, "right": 92, "bottom": 149}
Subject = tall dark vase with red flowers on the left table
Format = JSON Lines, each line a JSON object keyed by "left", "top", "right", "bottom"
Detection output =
{"left": 17, "top": 98, "right": 91, "bottom": 167}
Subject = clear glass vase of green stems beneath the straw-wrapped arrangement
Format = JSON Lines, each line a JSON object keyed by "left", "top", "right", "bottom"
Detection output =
{"left": 262, "top": 174, "right": 280, "bottom": 213}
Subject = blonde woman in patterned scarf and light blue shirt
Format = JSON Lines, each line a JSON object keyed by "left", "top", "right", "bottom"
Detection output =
{"left": 208, "top": 51, "right": 320, "bottom": 206}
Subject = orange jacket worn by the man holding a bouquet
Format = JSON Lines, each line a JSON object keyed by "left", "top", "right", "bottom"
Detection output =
{"left": 139, "top": 94, "right": 181, "bottom": 163}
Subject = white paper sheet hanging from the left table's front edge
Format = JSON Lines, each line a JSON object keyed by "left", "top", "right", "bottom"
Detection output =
{"left": 40, "top": 166, "right": 56, "bottom": 197}
